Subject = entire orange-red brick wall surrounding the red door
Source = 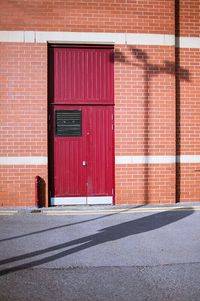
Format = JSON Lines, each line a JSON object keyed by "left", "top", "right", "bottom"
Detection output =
{"left": 0, "top": 0, "right": 200, "bottom": 206}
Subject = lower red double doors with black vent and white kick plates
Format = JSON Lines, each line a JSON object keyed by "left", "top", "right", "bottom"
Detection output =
{"left": 51, "top": 105, "right": 114, "bottom": 205}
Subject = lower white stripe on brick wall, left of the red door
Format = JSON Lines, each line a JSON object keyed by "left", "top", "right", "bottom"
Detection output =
{"left": 0, "top": 157, "right": 47, "bottom": 165}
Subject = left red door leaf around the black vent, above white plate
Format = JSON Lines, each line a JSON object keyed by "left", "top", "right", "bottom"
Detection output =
{"left": 52, "top": 106, "right": 87, "bottom": 197}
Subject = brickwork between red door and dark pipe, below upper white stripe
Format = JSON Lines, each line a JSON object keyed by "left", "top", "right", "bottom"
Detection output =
{"left": 115, "top": 45, "right": 176, "bottom": 203}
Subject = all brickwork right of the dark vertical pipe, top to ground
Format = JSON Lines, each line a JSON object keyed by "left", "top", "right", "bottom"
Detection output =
{"left": 177, "top": 0, "right": 200, "bottom": 202}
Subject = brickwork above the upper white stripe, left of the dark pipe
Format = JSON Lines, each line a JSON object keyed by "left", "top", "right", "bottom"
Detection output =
{"left": 0, "top": 0, "right": 174, "bottom": 34}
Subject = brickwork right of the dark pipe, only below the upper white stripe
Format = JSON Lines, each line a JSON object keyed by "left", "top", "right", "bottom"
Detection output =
{"left": 177, "top": 48, "right": 200, "bottom": 202}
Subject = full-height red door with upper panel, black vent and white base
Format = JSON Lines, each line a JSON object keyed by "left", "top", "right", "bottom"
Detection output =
{"left": 48, "top": 45, "right": 114, "bottom": 205}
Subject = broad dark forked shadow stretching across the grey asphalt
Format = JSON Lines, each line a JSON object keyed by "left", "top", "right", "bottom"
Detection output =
{"left": 0, "top": 207, "right": 194, "bottom": 275}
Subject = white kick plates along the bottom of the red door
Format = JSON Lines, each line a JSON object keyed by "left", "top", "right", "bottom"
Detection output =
{"left": 51, "top": 196, "right": 113, "bottom": 206}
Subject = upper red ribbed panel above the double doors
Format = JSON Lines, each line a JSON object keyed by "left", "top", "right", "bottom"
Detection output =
{"left": 49, "top": 46, "right": 114, "bottom": 105}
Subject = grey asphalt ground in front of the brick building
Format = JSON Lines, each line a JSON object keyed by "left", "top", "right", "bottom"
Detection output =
{"left": 0, "top": 206, "right": 200, "bottom": 301}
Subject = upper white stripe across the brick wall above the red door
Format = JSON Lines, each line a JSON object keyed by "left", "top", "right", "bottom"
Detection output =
{"left": 0, "top": 31, "right": 200, "bottom": 48}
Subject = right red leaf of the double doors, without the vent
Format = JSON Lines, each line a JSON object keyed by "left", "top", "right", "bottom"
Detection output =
{"left": 87, "top": 106, "right": 113, "bottom": 196}
